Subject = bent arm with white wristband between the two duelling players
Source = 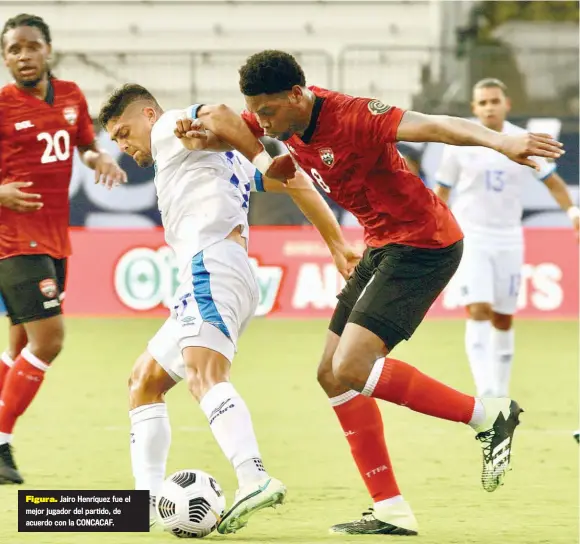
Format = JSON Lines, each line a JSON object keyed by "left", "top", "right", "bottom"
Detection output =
{"left": 175, "top": 104, "right": 296, "bottom": 182}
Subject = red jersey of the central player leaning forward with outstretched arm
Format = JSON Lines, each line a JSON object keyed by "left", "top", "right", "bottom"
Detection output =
{"left": 242, "top": 87, "right": 463, "bottom": 248}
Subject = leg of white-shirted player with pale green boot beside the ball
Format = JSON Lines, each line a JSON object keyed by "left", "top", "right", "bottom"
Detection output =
{"left": 182, "top": 346, "right": 286, "bottom": 534}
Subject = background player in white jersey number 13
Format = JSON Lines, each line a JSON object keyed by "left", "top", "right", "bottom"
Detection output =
{"left": 435, "top": 79, "right": 580, "bottom": 397}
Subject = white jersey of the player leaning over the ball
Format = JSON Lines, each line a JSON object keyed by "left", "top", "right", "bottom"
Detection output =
{"left": 151, "top": 108, "right": 263, "bottom": 278}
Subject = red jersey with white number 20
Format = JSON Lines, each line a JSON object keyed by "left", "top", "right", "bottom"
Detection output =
{"left": 0, "top": 79, "right": 95, "bottom": 259}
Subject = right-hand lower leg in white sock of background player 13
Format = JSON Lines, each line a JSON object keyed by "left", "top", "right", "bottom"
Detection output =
{"left": 490, "top": 312, "right": 515, "bottom": 398}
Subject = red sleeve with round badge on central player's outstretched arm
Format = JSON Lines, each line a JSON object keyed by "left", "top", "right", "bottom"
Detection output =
{"left": 344, "top": 98, "right": 405, "bottom": 149}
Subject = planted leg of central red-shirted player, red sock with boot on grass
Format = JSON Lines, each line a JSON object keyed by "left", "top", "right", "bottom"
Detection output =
{"left": 318, "top": 331, "right": 417, "bottom": 535}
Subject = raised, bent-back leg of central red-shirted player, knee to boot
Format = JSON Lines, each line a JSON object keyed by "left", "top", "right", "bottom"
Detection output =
{"left": 333, "top": 323, "right": 522, "bottom": 498}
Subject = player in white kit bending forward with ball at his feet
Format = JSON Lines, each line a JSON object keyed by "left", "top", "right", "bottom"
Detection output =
{"left": 99, "top": 85, "right": 356, "bottom": 533}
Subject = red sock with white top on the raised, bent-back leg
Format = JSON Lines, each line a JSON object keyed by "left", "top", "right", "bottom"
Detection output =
{"left": 363, "top": 358, "right": 475, "bottom": 423}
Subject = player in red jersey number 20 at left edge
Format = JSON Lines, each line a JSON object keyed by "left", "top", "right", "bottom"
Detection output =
{"left": 0, "top": 14, "right": 126, "bottom": 484}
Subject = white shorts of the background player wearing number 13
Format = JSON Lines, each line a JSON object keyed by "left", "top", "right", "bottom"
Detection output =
{"left": 454, "top": 240, "right": 524, "bottom": 315}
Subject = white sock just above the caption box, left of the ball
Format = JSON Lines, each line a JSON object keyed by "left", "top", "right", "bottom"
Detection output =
{"left": 129, "top": 402, "right": 171, "bottom": 497}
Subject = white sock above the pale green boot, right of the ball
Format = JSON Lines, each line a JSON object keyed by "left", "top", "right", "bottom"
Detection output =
{"left": 199, "top": 382, "right": 268, "bottom": 488}
